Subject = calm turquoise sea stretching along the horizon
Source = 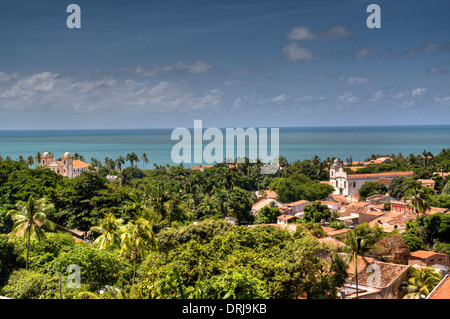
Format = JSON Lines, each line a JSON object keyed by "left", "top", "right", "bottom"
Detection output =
{"left": 0, "top": 125, "right": 450, "bottom": 168}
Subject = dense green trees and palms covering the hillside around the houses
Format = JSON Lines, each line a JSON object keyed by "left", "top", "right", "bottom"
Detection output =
{"left": 0, "top": 150, "right": 450, "bottom": 299}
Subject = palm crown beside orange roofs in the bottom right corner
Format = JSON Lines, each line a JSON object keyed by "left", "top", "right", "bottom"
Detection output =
{"left": 402, "top": 267, "right": 442, "bottom": 299}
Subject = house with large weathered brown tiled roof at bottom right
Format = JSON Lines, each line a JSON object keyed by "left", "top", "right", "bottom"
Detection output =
{"left": 340, "top": 254, "right": 411, "bottom": 299}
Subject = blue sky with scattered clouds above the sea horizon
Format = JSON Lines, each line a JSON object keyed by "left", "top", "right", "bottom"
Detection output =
{"left": 0, "top": 0, "right": 450, "bottom": 130}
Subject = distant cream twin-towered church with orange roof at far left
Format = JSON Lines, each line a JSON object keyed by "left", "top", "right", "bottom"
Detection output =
{"left": 39, "top": 151, "right": 95, "bottom": 178}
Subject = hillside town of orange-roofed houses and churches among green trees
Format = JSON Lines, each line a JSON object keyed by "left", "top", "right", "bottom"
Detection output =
{"left": 0, "top": 150, "right": 450, "bottom": 299}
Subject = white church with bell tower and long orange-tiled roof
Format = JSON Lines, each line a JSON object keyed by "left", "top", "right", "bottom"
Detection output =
{"left": 330, "top": 158, "right": 414, "bottom": 196}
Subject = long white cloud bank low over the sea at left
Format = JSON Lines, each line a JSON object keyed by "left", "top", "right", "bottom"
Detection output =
{"left": 0, "top": 72, "right": 223, "bottom": 112}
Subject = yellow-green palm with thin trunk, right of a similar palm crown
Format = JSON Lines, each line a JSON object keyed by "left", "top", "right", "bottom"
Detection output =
{"left": 120, "top": 217, "right": 156, "bottom": 284}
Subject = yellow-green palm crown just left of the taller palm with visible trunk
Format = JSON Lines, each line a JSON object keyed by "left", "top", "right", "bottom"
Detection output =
{"left": 91, "top": 212, "right": 123, "bottom": 250}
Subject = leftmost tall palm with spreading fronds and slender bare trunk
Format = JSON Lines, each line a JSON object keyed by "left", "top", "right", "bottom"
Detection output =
{"left": 7, "top": 196, "right": 56, "bottom": 270}
